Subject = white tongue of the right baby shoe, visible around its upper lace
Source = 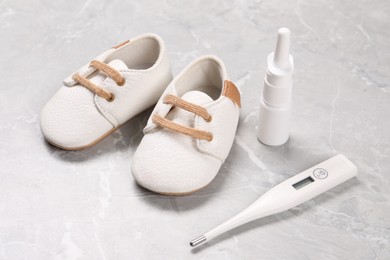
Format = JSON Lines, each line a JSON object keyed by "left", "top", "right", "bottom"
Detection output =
{"left": 168, "top": 91, "right": 213, "bottom": 127}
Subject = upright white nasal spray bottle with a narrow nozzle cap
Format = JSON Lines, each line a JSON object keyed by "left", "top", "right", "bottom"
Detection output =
{"left": 257, "top": 28, "right": 294, "bottom": 146}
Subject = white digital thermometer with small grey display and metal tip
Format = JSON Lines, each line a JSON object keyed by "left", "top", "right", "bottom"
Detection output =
{"left": 190, "top": 154, "right": 357, "bottom": 247}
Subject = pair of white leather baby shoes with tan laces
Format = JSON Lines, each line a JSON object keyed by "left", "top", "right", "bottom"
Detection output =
{"left": 41, "top": 34, "right": 241, "bottom": 195}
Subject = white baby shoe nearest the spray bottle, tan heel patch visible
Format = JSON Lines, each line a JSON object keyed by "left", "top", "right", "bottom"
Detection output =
{"left": 132, "top": 56, "right": 240, "bottom": 195}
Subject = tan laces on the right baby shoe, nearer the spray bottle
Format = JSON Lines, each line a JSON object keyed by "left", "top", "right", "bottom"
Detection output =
{"left": 152, "top": 95, "right": 213, "bottom": 141}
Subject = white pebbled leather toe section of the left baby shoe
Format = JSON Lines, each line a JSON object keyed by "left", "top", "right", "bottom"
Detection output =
{"left": 41, "top": 82, "right": 112, "bottom": 147}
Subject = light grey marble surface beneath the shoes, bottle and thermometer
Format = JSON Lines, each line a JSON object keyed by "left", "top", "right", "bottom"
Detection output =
{"left": 0, "top": 0, "right": 390, "bottom": 260}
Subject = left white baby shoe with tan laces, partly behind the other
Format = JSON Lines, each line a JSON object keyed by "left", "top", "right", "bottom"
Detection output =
{"left": 41, "top": 34, "right": 172, "bottom": 150}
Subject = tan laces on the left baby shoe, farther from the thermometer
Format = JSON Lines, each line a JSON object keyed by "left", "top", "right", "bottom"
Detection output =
{"left": 72, "top": 60, "right": 125, "bottom": 102}
